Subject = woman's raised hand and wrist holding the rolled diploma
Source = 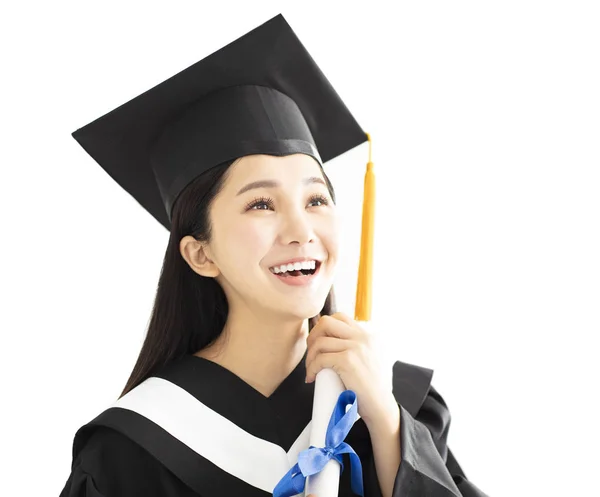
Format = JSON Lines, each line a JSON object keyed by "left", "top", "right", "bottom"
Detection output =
{"left": 306, "top": 312, "right": 398, "bottom": 427}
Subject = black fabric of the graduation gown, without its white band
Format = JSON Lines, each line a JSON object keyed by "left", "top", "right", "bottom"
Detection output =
{"left": 60, "top": 356, "right": 486, "bottom": 497}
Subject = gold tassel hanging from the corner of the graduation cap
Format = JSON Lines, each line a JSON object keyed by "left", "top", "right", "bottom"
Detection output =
{"left": 354, "top": 133, "right": 375, "bottom": 321}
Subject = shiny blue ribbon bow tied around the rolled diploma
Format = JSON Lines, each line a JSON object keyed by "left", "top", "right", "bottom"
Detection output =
{"left": 273, "top": 390, "right": 363, "bottom": 497}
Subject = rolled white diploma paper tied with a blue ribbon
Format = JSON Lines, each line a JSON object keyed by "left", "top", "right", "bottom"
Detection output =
{"left": 304, "top": 369, "right": 346, "bottom": 497}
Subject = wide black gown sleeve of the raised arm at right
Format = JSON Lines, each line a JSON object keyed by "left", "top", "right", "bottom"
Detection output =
{"left": 393, "top": 386, "right": 487, "bottom": 497}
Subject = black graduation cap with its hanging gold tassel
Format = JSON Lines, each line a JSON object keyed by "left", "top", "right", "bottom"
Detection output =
{"left": 72, "top": 14, "right": 374, "bottom": 320}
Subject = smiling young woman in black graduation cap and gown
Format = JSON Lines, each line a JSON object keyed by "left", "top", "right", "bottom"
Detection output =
{"left": 61, "top": 15, "right": 485, "bottom": 497}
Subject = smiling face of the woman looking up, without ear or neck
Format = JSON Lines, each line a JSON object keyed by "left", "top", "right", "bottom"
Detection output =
{"left": 197, "top": 154, "right": 339, "bottom": 319}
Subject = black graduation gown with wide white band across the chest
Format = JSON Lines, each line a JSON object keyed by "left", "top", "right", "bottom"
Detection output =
{"left": 60, "top": 355, "right": 486, "bottom": 497}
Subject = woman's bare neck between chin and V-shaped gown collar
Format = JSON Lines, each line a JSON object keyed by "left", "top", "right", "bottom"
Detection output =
{"left": 194, "top": 309, "right": 308, "bottom": 397}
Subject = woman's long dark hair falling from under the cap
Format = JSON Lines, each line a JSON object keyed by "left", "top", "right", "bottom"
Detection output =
{"left": 119, "top": 159, "right": 335, "bottom": 398}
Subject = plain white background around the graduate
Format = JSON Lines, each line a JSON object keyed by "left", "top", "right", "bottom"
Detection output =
{"left": 0, "top": 0, "right": 600, "bottom": 496}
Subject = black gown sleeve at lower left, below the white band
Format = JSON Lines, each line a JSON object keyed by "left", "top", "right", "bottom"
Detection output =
{"left": 60, "top": 427, "right": 198, "bottom": 497}
